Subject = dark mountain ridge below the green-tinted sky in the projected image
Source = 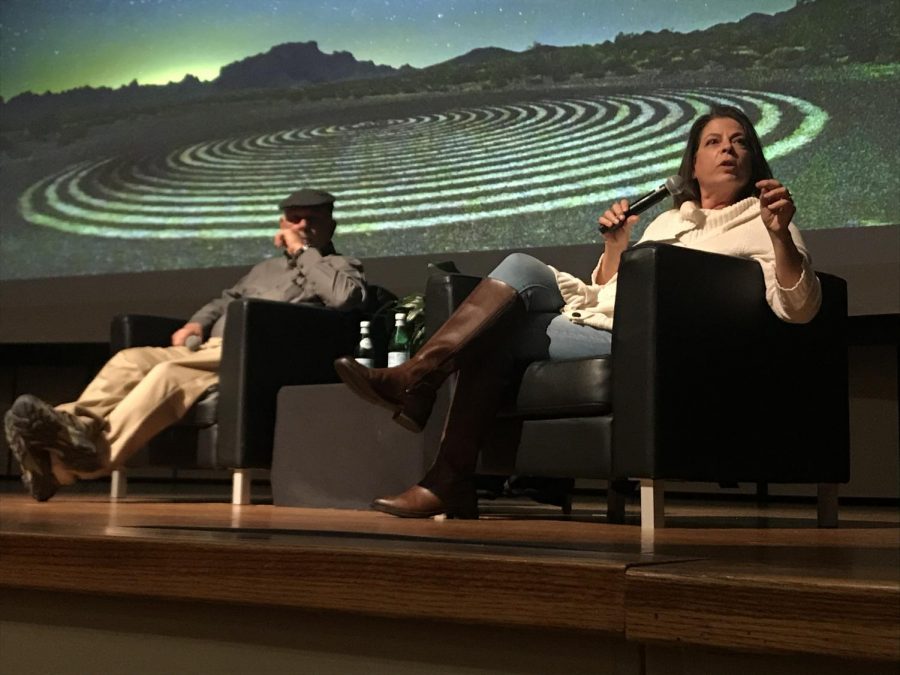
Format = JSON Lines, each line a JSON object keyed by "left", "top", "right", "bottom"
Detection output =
{"left": 0, "top": 0, "right": 900, "bottom": 131}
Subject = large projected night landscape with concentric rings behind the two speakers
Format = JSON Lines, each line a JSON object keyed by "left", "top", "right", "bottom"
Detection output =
{"left": 0, "top": 0, "right": 900, "bottom": 279}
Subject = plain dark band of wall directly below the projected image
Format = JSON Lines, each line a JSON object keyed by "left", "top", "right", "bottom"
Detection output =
{"left": 0, "top": 226, "right": 900, "bottom": 343}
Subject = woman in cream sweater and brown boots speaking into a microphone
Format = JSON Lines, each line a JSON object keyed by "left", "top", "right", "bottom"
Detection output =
{"left": 335, "top": 106, "right": 821, "bottom": 518}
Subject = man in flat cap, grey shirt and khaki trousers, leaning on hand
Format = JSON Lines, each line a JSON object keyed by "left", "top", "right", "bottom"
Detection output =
{"left": 4, "top": 189, "right": 366, "bottom": 501}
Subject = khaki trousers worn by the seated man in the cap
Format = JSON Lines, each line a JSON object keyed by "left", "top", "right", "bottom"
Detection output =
{"left": 51, "top": 338, "right": 222, "bottom": 484}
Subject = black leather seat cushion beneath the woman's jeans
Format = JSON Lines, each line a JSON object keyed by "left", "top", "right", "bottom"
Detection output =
{"left": 516, "top": 357, "right": 612, "bottom": 419}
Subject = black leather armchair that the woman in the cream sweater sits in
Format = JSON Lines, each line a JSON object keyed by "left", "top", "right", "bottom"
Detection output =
{"left": 426, "top": 243, "right": 849, "bottom": 528}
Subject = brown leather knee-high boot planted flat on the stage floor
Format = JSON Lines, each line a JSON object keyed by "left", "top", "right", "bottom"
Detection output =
{"left": 372, "top": 349, "right": 513, "bottom": 518}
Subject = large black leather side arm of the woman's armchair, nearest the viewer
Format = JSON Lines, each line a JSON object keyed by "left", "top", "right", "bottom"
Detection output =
{"left": 612, "top": 243, "right": 849, "bottom": 483}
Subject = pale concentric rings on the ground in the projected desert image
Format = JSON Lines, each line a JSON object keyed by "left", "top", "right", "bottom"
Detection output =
{"left": 19, "top": 89, "right": 828, "bottom": 239}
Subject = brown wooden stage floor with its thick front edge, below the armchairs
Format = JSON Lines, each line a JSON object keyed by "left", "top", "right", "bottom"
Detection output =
{"left": 0, "top": 488, "right": 900, "bottom": 661}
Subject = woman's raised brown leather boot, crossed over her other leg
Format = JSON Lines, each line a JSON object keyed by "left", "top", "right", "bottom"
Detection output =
{"left": 334, "top": 278, "right": 524, "bottom": 431}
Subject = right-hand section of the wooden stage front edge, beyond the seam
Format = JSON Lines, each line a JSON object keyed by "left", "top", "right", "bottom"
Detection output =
{"left": 625, "top": 551, "right": 900, "bottom": 660}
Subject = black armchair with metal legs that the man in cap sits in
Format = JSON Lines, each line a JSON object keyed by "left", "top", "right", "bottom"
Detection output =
{"left": 110, "top": 286, "right": 396, "bottom": 504}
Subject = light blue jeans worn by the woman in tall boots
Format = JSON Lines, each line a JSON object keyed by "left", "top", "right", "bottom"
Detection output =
{"left": 488, "top": 253, "right": 612, "bottom": 361}
